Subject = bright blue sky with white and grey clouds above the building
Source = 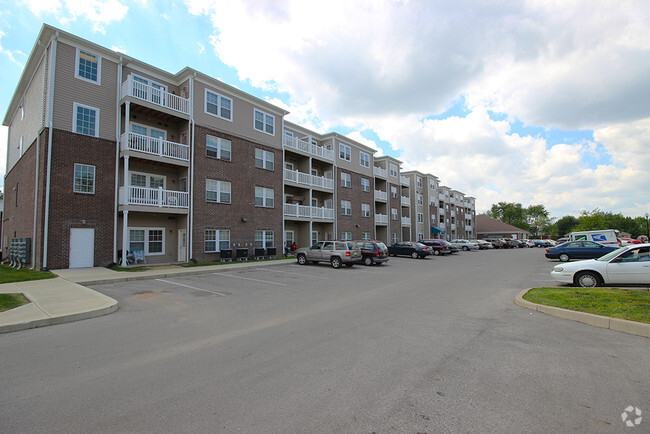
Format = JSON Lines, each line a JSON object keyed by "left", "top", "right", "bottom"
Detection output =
{"left": 0, "top": 0, "right": 650, "bottom": 217}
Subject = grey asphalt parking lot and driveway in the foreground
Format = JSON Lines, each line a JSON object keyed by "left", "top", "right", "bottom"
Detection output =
{"left": 0, "top": 249, "right": 650, "bottom": 432}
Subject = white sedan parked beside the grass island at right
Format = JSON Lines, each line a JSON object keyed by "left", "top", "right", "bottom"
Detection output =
{"left": 551, "top": 243, "right": 650, "bottom": 288}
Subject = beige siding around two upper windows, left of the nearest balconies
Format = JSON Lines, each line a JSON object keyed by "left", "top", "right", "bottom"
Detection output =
{"left": 53, "top": 42, "right": 117, "bottom": 140}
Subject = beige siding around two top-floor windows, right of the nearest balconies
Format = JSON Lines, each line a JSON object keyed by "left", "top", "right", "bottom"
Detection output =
{"left": 194, "top": 80, "right": 283, "bottom": 149}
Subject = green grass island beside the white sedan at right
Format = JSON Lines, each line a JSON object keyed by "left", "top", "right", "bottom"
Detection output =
{"left": 524, "top": 287, "right": 650, "bottom": 324}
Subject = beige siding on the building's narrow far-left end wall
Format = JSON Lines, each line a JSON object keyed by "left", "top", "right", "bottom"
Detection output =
{"left": 7, "top": 51, "right": 46, "bottom": 171}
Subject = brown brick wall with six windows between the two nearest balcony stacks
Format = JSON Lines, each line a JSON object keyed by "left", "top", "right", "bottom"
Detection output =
{"left": 191, "top": 126, "right": 284, "bottom": 262}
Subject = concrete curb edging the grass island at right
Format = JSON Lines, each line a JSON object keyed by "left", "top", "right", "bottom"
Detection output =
{"left": 514, "top": 288, "right": 650, "bottom": 338}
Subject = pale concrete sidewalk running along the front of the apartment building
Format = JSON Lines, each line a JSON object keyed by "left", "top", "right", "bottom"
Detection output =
{"left": 0, "top": 258, "right": 296, "bottom": 333}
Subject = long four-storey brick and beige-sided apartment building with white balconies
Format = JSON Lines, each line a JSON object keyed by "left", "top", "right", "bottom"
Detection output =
{"left": 2, "top": 25, "right": 473, "bottom": 268}
